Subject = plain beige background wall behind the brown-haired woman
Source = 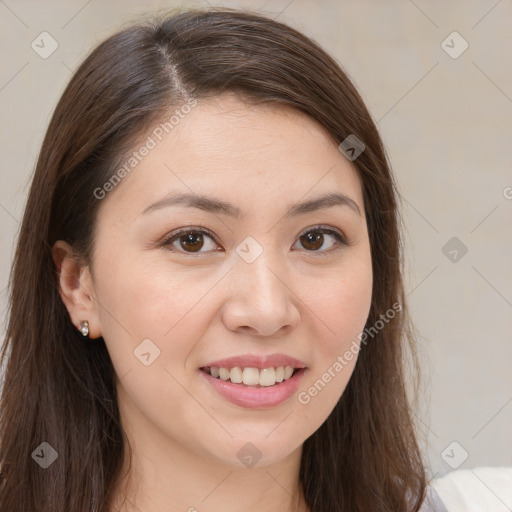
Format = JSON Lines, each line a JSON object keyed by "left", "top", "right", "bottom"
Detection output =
{"left": 0, "top": 0, "right": 512, "bottom": 485}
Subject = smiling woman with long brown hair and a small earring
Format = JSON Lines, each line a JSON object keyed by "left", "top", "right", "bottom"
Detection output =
{"left": 0, "top": 9, "right": 444, "bottom": 512}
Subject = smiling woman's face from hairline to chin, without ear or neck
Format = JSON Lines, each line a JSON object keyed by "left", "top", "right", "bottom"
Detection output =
{"left": 85, "top": 96, "right": 372, "bottom": 467}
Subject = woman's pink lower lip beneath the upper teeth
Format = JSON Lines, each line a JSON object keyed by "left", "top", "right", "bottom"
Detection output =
{"left": 199, "top": 368, "right": 306, "bottom": 409}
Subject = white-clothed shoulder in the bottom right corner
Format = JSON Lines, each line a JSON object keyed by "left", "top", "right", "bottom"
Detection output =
{"left": 428, "top": 467, "right": 512, "bottom": 512}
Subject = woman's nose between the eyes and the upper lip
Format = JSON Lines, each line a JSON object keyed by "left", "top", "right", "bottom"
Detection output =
{"left": 222, "top": 251, "right": 300, "bottom": 337}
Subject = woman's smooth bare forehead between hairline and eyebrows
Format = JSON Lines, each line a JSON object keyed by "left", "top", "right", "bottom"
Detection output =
{"left": 98, "top": 95, "right": 362, "bottom": 220}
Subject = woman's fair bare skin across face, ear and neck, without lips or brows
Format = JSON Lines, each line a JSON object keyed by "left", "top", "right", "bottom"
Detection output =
{"left": 53, "top": 95, "right": 372, "bottom": 512}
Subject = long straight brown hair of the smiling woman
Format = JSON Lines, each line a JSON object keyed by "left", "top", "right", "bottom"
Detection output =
{"left": 0, "top": 8, "right": 426, "bottom": 512}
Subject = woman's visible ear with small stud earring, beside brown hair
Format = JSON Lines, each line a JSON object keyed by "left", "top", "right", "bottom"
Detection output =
{"left": 52, "top": 240, "right": 101, "bottom": 339}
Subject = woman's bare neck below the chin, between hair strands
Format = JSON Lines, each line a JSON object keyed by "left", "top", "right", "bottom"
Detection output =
{"left": 110, "top": 424, "right": 308, "bottom": 512}
